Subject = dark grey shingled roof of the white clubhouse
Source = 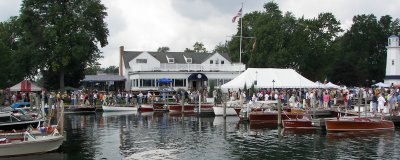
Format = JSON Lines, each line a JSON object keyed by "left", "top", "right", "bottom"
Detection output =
{"left": 123, "top": 51, "right": 231, "bottom": 68}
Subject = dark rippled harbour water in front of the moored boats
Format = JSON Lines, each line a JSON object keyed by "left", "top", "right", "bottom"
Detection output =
{"left": 3, "top": 113, "right": 400, "bottom": 160}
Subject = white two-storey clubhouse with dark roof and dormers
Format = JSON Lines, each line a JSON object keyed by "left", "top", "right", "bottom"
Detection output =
{"left": 119, "top": 46, "right": 246, "bottom": 90}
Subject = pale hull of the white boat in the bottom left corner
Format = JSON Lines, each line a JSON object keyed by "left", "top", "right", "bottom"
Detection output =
{"left": 0, "top": 136, "right": 64, "bottom": 156}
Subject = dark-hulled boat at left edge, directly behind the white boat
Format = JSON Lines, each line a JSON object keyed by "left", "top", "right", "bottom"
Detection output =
{"left": 0, "top": 112, "right": 44, "bottom": 131}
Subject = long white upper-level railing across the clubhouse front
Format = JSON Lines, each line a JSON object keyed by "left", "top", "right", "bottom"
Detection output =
{"left": 130, "top": 63, "right": 246, "bottom": 72}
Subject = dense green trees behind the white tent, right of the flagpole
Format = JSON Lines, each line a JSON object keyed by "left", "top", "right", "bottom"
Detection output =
{"left": 223, "top": 2, "right": 400, "bottom": 86}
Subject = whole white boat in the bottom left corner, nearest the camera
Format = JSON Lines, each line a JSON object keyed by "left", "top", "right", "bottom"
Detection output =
{"left": 0, "top": 132, "right": 64, "bottom": 157}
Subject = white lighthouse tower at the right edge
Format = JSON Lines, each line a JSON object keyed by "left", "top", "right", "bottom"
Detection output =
{"left": 385, "top": 35, "right": 400, "bottom": 86}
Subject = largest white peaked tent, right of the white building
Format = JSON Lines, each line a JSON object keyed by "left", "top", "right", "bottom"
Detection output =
{"left": 221, "top": 68, "right": 318, "bottom": 89}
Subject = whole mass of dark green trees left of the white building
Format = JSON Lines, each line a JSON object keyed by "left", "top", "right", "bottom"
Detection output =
{"left": 0, "top": 0, "right": 109, "bottom": 90}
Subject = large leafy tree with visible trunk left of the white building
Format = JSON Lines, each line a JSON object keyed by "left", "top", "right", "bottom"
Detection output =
{"left": 20, "top": 0, "right": 108, "bottom": 91}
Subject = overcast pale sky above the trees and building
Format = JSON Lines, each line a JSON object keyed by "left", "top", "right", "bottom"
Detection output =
{"left": 0, "top": 0, "right": 400, "bottom": 67}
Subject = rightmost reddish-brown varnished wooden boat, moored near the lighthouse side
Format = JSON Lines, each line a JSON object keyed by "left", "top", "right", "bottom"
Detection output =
{"left": 325, "top": 118, "right": 394, "bottom": 131}
